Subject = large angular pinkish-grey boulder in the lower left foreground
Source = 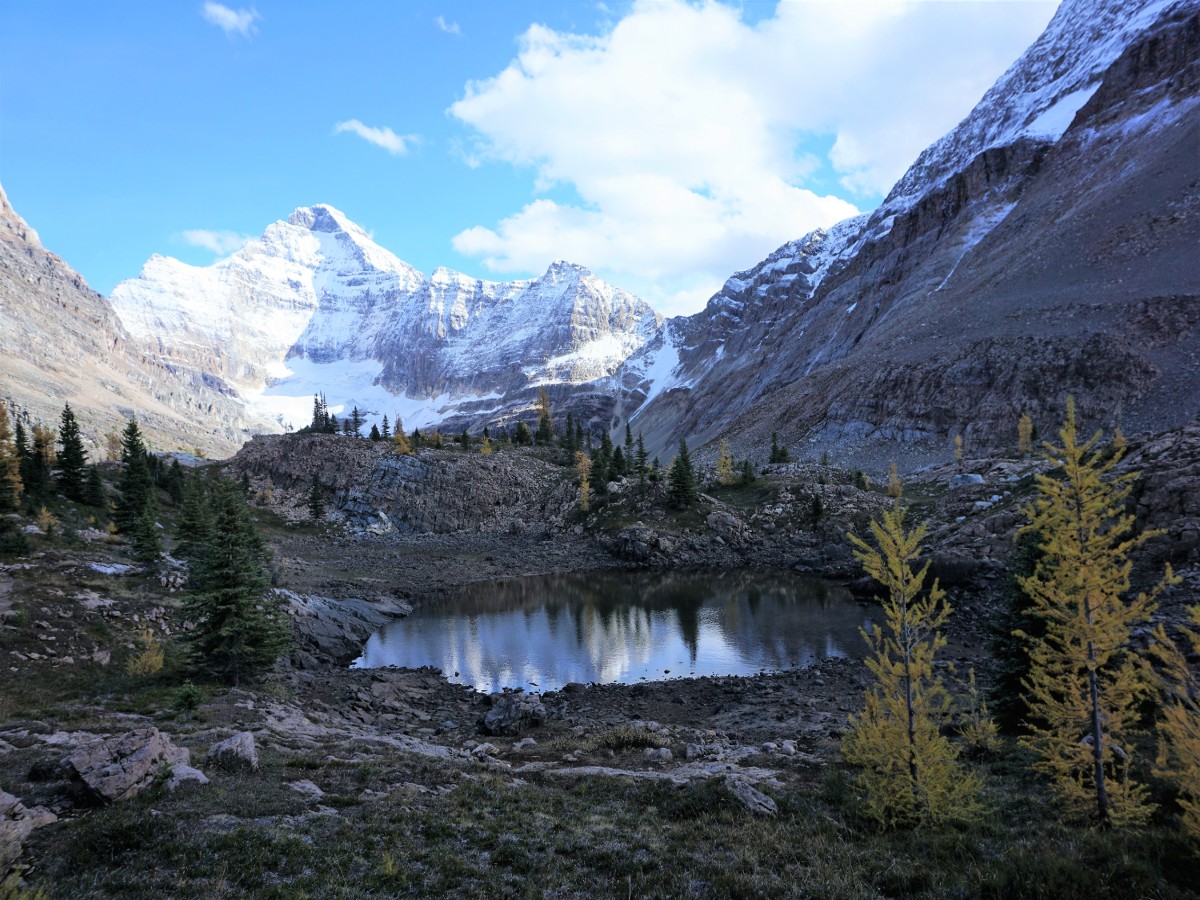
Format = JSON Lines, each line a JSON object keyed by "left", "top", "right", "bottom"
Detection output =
{"left": 61, "top": 728, "right": 191, "bottom": 803}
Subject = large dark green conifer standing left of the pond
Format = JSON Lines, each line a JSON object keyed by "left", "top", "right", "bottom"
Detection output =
{"left": 182, "top": 479, "right": 290, "bottom": 684}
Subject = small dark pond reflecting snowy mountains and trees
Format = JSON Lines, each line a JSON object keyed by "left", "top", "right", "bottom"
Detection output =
{"left": 354, "top": 571, "right": 872, "bottom": 691}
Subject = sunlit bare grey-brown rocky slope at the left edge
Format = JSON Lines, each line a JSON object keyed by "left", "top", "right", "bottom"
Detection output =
{"left": 0, "top": 188, "right": 269, "bottom": 454}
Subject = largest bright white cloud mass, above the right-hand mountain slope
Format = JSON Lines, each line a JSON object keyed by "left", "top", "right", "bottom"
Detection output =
{"left": 450, "top": 0, "right": 1057, "bottom": 311}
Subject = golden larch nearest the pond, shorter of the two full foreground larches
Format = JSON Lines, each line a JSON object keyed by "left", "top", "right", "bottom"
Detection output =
{"left": 842, "top": 502, "right": 979, "bottom": 827}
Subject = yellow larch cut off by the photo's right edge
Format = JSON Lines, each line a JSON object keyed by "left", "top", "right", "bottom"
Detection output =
{"left": 1153, "top": 606, "right": 1200, "bottom": 840}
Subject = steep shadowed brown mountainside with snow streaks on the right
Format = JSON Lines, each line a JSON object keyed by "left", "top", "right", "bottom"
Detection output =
{"left": 637, "top": 0, "right": 1200, "bottom": 466}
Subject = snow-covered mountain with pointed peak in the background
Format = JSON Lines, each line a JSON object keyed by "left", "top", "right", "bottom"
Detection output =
{"left": 112, "top": 205, "right": 662, "bottom": 441}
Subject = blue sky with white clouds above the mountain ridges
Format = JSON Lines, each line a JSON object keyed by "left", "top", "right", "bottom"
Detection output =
{"left": 0, "top": 0, "right": 1057, "bottom": 313}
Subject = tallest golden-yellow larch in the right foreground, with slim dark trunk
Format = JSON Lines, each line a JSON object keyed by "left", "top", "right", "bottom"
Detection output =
{"left": 1016, "top": 400, "right": 1171, "bottom": 824}
